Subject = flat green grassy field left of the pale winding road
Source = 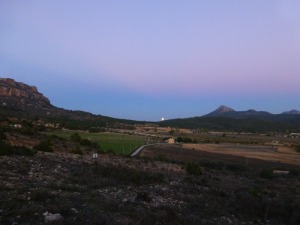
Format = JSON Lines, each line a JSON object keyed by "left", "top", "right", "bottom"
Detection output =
{"left": 46, "top": 131, "right": 145, "bottom": 154}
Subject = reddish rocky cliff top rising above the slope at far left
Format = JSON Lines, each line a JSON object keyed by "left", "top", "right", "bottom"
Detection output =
{"left": 0, "top": 78, "right": 50, "bottom": 104}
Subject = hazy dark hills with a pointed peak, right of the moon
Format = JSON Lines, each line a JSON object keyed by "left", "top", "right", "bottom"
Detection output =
{"left": 160, "top": 106, "right": 300, "bottom": 132}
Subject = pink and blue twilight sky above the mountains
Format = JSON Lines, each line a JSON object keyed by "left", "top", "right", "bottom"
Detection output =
{"left": 0, "top": 0, "right": 300, "bottom": 121}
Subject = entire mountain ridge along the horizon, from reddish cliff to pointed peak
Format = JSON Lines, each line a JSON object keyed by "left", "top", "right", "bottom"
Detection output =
{"left": 0, "top": 78, "right": 300, "bottom": 131}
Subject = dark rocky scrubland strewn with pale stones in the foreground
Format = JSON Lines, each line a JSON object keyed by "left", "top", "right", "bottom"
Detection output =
{"left": 0, "top": 149, "right": 300, "bottom": 225}
